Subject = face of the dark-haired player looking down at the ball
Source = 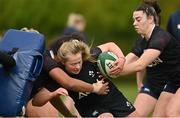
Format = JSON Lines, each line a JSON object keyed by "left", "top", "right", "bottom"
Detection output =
{"left": 133, "top": 11, "right": 148, "bottom": 35}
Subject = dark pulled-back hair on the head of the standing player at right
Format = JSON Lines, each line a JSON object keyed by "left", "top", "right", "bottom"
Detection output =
{"left": 135, "top": 3, "right": 158, "bottom": 25}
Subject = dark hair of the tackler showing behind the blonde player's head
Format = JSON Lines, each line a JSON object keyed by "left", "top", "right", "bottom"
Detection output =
{"left": 48, "top": 32, "right": 85, "bottom": 55}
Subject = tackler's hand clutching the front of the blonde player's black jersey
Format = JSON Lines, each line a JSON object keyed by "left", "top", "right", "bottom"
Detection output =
{"left": 93, "top": 80, "right": 109, "bottom": 95}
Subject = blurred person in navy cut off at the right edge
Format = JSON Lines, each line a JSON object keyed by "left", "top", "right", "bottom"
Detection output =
{"left": 167, "top": 10, "right": 180, "bottom": 41}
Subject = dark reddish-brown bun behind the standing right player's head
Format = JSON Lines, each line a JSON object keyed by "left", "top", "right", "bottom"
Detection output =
{"left": 143, "top": 0, "right": 161, "bottom": 25}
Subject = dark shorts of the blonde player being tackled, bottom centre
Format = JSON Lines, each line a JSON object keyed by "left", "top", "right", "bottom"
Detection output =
{"left": 76, "top": 89, "right": 135, "bottom": 117}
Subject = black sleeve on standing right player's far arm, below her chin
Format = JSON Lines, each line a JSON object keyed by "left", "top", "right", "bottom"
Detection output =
{"left": 131, "top": 39, "right": 143, "bottom": 57}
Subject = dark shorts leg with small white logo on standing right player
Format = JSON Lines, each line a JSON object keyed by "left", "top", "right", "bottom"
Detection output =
{"left": 139, "top": 82, "right": 163, "bottom": 99}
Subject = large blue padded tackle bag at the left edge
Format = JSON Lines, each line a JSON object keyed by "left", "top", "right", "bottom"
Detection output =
{"left": 0, "top": 29, "right": 45, "bottom": 116}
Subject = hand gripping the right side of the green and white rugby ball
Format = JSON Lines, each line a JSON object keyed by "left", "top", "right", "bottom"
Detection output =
{"left": 109, "top": 57, "right": 125, "bottom": 76}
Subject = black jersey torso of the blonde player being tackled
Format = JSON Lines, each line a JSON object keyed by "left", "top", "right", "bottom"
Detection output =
{"left": 60, "top": 61, "right": 129, "bottom": 116}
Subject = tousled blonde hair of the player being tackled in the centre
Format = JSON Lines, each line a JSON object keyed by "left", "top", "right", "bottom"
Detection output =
{"left": 57, "top": 39, "right": 94, "bottom": 62}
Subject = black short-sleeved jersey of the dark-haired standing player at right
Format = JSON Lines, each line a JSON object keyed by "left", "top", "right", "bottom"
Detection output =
{"left": 132, "top": 26, "right": 180, "bottom": 83}
